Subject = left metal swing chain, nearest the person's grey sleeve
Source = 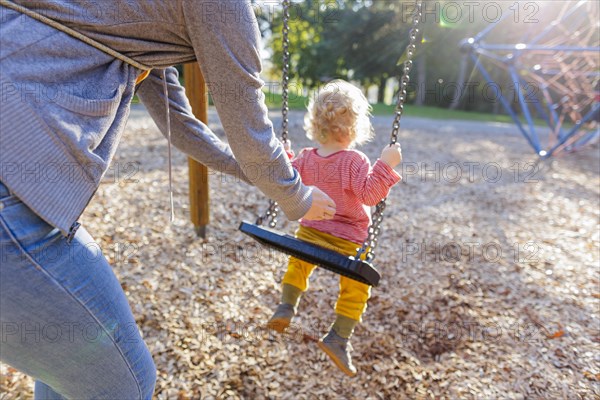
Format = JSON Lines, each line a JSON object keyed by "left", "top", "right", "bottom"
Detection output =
{"left": 256, "top": 0, "right": 290, "bottom": 228}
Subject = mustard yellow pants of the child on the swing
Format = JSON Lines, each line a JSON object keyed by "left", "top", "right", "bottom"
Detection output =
{"left": 283, "top": 225, "right": 371, "bottom": 321}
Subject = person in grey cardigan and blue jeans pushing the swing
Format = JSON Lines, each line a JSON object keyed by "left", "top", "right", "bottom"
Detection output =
{"left": 0, "top": 0, "right": 335, "bottom": 399}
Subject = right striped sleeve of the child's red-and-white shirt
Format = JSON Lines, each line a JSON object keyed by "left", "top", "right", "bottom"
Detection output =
{"left": 350, "top": 157, "right": 402, "bottom": 206}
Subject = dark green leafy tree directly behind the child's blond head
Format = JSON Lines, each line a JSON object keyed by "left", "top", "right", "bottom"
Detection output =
{"left": 269, "top": 1, "right": 408, "bottom": 94}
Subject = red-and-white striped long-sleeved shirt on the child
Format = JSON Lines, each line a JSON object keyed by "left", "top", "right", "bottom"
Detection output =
{"left": 288, "top": 148, "right": 401, "bottom": 243}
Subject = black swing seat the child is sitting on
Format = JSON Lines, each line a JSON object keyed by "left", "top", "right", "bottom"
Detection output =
{"left": 240, "top": 221, "right": 381, "bottom": 286}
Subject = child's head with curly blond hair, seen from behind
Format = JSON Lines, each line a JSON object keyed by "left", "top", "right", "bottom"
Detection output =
{"left": 304, "top": 79, "right": 373, "bottom": 147}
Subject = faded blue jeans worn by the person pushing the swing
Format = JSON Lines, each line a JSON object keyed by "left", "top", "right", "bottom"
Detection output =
{"left": 0, "top": 182, "right": 156, "bottom": 400}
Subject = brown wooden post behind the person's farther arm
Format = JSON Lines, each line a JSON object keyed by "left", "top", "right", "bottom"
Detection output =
{"left": 183, "top": 63, "right": 210, "bottom": 238}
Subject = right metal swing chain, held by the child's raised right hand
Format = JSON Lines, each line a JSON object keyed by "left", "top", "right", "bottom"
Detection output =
{"left": 356, "top": 0, "right": 422, "bottom": 262}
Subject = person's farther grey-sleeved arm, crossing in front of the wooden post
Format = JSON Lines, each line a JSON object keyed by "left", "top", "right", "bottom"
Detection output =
{"left": 137, "top": 68, "right": 250, "bottom": 183}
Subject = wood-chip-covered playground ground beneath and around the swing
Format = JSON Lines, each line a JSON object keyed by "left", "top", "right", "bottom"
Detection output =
{"left": 0, "top": 106, "right": 600, "bottom": 400}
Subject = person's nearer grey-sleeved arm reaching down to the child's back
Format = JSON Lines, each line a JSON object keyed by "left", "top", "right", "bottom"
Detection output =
{"left": 182, "top": 0, "right": 314, "bottom": 220}
